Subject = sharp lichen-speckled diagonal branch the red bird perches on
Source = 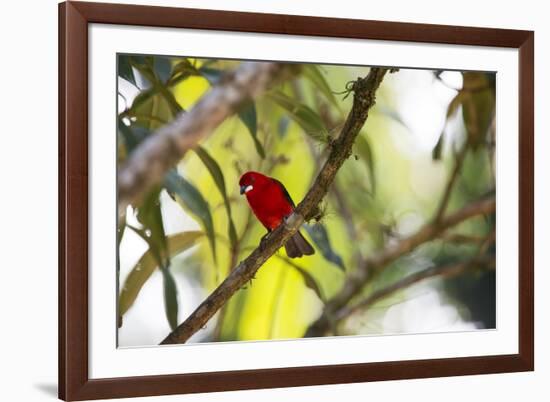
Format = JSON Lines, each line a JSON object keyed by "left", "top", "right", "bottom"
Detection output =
{"left": 161, "top": 68, "right": 387, "bottom": 344}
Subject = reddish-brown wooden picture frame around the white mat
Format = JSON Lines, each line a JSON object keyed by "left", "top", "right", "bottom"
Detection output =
{"left": 59, "top": 2, "right": 534, "bottom": 400}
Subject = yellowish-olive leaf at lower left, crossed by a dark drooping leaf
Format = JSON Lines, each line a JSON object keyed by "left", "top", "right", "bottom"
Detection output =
{"left": 119, "top": 231, "right": 203, "bottom": 315}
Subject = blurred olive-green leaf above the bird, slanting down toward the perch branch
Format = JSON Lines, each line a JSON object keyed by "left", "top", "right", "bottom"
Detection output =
{"left": 267, "top": 91, "right": 329, "bottom": 143}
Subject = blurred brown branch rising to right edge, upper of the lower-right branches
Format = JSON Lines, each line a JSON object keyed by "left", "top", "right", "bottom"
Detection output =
{"left": 305, "top": 197, "right": 496, "bottom": 337}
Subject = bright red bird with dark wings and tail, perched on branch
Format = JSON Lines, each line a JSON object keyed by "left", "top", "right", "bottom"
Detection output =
{"left": 239, "top": 172, "right": 315, "bottom": 258}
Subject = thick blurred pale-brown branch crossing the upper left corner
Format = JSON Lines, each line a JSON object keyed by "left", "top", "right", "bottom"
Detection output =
{"left": 118, "top": 62, "right": 285, "bottom": 214}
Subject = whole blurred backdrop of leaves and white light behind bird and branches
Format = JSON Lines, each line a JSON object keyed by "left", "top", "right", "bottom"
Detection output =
{"left": 117, "top": 55, "right": 496, "bottom": 347}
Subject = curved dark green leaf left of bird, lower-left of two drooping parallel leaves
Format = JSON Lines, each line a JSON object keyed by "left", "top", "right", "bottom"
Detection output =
{"left": 164, "top": 170, "right": 216, "bottom": 261}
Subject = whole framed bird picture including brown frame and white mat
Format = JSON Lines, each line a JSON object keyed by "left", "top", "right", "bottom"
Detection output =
{"left": 59, "top": 1, "right": 534, "bottom": 400}
